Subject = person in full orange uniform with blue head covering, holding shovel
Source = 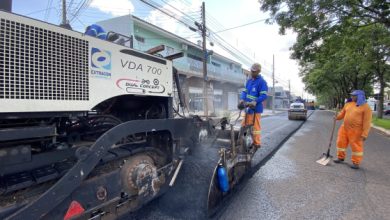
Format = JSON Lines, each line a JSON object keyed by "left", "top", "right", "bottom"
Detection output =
{"left": 334, "top": 90, "right": 372, "bottom": 169}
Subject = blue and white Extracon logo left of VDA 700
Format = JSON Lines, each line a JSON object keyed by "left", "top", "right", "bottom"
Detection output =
{"left": 91, "top": 47, "right": 111, "bottom": 78}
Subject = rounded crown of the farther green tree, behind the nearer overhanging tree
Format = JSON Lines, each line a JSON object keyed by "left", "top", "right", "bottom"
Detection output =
{"left": 301, "top": 26, "right": 375, "bottom": 107}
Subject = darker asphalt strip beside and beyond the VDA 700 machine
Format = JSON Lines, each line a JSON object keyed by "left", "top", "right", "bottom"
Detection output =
{"left": 123, "top": 113, "right": 310, "bottom": 219}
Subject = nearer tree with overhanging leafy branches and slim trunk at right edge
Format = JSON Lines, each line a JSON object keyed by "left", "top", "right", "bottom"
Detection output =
{"left": 259, "top": 0, "right": 390, "bottom": 117}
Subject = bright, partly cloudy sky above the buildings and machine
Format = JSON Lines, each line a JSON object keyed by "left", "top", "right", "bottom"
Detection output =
{"left": 13, "top": 0, "right": 313, "bottom": 98}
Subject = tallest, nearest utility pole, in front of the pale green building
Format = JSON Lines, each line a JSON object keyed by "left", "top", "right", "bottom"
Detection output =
{"left": 201, "top": 2, "right": 209, "bottom": 119}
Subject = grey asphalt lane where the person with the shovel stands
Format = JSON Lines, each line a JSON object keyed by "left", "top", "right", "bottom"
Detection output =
{"left": 219, "top": 111, "right": 390, "bottom": 219}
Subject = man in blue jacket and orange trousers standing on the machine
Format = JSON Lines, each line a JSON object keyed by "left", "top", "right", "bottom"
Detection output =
{"left": 238, "top": 63, "right": 268, "bottom": 150}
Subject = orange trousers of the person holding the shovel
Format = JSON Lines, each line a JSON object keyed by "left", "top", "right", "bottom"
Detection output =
{"left": 337, "top": 125, "right": 363, "bottom": 165}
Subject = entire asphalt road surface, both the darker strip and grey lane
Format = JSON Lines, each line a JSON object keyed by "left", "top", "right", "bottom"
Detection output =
{"left": 124, "top": 111, "right": 390, "bottom": 219}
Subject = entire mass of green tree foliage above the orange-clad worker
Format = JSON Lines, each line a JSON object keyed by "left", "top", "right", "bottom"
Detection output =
{"left": 259, "top": 0, "right": 390, "bottom": 111}
